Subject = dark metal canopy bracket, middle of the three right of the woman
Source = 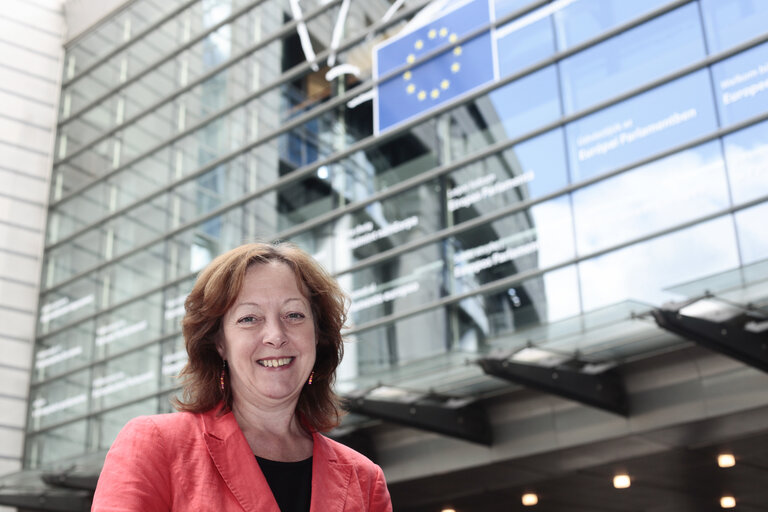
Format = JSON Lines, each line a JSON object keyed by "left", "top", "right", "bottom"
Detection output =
{"left": 477, "top": 357, "right": 629, "bottom": 416}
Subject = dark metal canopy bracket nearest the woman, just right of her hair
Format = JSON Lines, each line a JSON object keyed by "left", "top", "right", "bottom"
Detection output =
{"left": 346, "top": 395, "right": 493, "bottom": 446}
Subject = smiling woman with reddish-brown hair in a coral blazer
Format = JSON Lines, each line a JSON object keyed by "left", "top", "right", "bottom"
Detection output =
{"left": 93, "top": 243, "right": 392, "bottom": 512}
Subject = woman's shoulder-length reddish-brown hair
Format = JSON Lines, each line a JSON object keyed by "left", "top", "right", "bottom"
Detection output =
{"left": 174, "top": 242, "right": 347, "bottom": 432}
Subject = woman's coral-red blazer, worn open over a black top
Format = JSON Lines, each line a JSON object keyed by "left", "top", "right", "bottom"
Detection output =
{"left": 91, "top": 411, "right": 392, "bottom": 512}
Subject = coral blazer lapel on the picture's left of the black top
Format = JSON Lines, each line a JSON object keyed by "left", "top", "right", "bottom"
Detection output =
{"left": 201, "top": 409, "right": 280, "bottom": 512}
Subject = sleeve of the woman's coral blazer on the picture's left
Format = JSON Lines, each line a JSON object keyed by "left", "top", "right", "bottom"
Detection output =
{"left": 91, "top": 416, "right": 171, "bottom": 512}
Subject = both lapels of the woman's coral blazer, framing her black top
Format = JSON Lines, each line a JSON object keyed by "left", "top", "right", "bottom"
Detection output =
{"left": 200, "top": 407, "right": 354, "bottom": 512}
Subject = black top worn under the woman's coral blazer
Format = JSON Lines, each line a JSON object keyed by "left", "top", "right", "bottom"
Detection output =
{"left": 256, "top": 456, "right": 312, "bottom": 512}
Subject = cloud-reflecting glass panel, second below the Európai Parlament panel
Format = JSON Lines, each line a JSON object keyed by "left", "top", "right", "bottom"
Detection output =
{"left": 579, "top": 215, "right": 739, "bottom": 311}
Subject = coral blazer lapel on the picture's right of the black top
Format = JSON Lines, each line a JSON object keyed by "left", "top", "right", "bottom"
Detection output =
{"left": 309, "top": 433, "right": 354, "bottom": 512}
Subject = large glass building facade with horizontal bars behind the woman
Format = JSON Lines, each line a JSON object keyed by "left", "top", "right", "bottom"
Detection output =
{"left": 25, "top": 0, "right": 768, "bottom": 468}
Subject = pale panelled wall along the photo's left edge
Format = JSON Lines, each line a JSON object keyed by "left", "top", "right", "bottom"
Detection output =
{"left": 0, "top": 0, "right": 64, "bottom": 510}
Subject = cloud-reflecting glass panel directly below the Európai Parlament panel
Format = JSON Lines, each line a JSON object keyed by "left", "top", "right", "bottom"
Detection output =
{"left": 573, "top": 141, "right": 729, "bottom": 254}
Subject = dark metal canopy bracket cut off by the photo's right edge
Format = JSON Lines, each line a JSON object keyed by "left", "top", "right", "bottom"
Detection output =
{"left": 653, "top": 309, "right": 768, "bottom": 373}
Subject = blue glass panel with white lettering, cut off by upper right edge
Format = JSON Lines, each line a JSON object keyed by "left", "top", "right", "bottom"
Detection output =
{"left": 712, "top": 40, "right": 768, "bottom": 126}
